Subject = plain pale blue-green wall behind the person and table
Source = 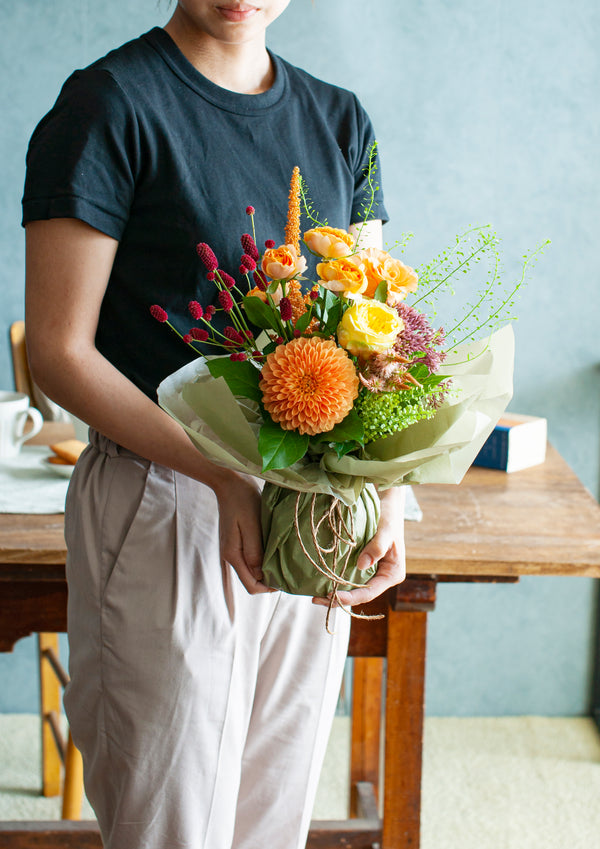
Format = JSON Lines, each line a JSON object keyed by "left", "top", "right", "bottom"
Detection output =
{"left": 0, "top": 0, "right": 600, "bottom": 715}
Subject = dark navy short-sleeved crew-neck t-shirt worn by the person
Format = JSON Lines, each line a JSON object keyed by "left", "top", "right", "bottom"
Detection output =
{"left": 23, "top": 28, "right": 387, "bottom": 400}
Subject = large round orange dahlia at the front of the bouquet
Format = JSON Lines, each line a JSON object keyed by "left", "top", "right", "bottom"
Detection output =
{"left": 259, "top": 336, "right": 358, "bottom": 436}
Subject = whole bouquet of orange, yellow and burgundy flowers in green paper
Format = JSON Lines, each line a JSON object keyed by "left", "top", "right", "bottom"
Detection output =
{"left": 151, "top": 155, "right": 544, "bottom": 624}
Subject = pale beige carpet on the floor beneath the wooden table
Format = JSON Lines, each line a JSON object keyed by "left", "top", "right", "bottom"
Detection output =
{"left": 0, "top": 714, "right": 600, "bottom": 849}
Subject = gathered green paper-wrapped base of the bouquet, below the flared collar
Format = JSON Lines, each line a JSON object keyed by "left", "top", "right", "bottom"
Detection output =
{"left": 262, "top": 483, "right": 380, "bottom": 597}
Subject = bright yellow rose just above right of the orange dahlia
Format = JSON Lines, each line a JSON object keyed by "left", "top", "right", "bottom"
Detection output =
{"left": 337, "top": 300, "right": 404, "bottom": 357}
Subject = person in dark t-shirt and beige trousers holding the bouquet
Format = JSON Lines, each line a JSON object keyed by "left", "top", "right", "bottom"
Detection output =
{"left": 23, "top": 0, "right": 404, "bottom": 849}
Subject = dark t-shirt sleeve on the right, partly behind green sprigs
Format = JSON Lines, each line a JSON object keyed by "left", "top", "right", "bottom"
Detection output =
{"left": 351, "top": 98, "right": 389, "bottom": 224}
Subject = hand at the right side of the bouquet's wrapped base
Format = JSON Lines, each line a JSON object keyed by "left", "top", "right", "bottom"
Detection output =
{"left": 313, "top": 487, "right": 406, "bottom": 607}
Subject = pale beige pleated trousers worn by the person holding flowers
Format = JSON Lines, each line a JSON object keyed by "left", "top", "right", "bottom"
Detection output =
{"left": 65, "top": 433, "right": 349, "bottom": 849}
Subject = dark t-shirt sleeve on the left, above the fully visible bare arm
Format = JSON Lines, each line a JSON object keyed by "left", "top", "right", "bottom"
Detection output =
{"left": 22, "top": 69, "right": 139, "bottom": 239}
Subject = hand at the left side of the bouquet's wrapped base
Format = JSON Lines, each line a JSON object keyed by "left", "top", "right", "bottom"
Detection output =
{"left": 213, "top": 470, "right": 274, "bottom": 595}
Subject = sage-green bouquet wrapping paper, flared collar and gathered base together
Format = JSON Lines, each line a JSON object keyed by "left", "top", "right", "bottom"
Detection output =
{"left": 158, "top": 326, "right": 514, "bottom": 595}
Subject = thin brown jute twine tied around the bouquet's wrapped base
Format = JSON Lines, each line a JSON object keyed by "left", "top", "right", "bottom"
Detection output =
{"left": 294, "top": 492, "right": 383, "bottom": 634}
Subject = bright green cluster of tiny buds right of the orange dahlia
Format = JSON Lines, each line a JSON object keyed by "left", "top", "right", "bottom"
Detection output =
{"left": 354, "top": 387, "right": 436, "bottom": 442}
